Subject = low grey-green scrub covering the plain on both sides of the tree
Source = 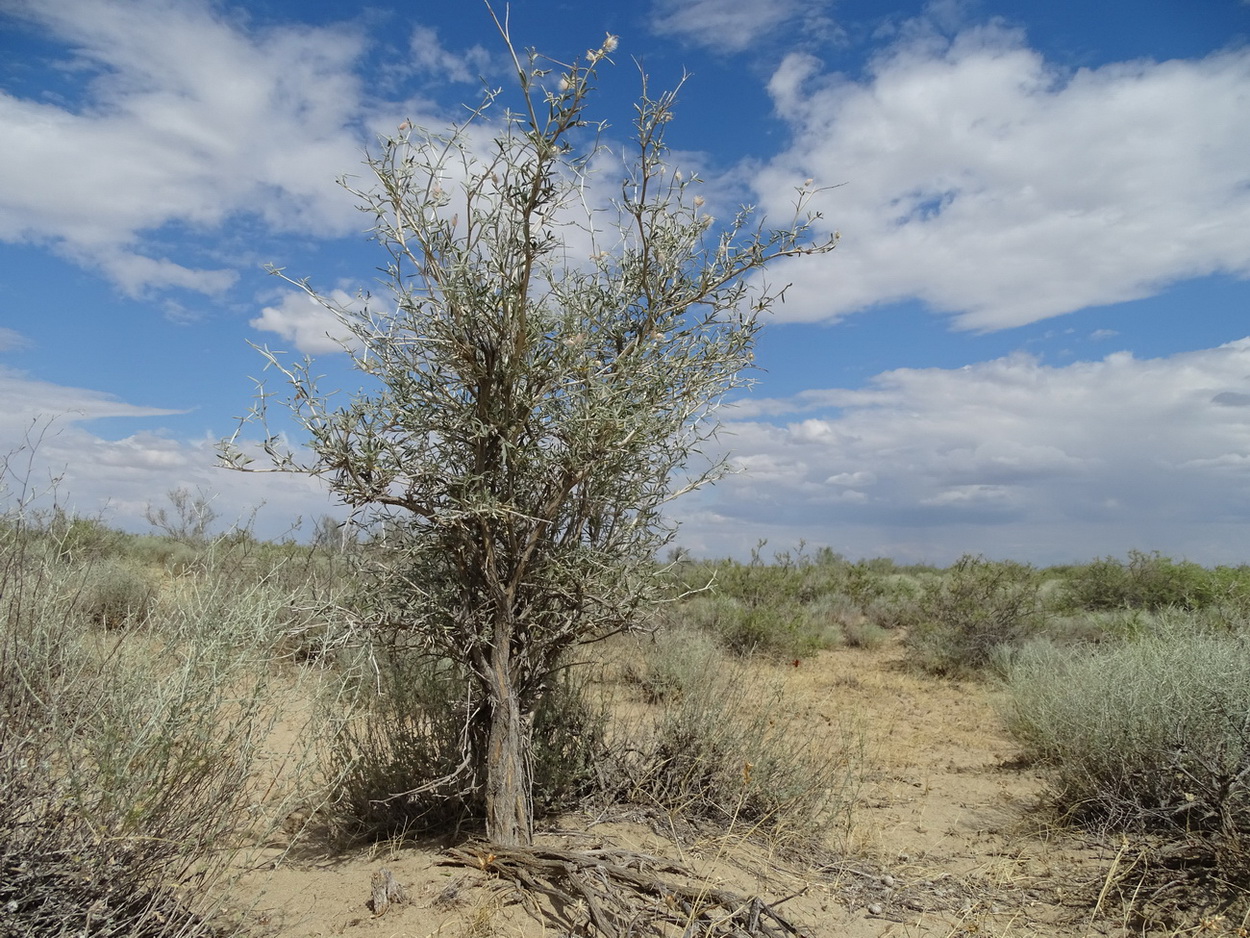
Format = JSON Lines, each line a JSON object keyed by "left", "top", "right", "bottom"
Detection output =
{"left": 0, "top": 480, "right": 1250, "bottom": 935}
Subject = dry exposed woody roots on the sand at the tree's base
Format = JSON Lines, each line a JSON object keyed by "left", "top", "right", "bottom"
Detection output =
{"left": 446, "top": 847, "right": 801, "bottom": 938}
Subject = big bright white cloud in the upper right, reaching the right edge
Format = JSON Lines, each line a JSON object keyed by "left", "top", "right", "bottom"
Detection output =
{"left": 756, "top": 18, "right": 1250, "bottom": 330}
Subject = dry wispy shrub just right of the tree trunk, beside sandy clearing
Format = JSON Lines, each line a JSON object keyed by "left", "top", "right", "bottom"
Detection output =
{"left": 609, "top": 649, "right": 860, "bottom": 849}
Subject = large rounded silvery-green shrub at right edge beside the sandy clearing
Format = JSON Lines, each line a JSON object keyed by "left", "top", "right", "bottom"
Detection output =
{"left": 1005, "top": 615, "right": 1250, "bottom": 833}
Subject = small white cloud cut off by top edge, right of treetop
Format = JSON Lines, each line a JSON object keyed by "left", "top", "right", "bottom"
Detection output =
{"left": 651, "top": 0, "right": 831, "bottom": 53}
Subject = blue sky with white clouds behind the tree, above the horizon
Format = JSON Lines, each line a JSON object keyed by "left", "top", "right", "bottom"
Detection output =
{"left": 0, "top": 0, "right": 1250, "bottom": 564}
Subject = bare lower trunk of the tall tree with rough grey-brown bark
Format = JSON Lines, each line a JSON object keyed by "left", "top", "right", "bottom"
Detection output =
{"left": 486, "top": 647, "right": 534, "bottom": 847}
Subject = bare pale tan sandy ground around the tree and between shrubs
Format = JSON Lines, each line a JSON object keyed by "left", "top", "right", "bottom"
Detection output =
{"left": 230, "top": 644, "right": 1195, "bottom": 938}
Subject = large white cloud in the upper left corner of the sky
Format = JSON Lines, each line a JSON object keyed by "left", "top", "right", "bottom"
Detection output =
{"left": 0, "top": 0, "right": 380, "bottom": 294}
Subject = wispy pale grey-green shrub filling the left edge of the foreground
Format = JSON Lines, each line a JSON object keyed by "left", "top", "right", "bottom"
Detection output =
{"left": 0, "top": 518, "right": 295, "bottom": 938}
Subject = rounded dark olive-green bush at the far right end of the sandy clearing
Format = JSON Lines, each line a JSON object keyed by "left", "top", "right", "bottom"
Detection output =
{"left": 905, "top": 557, "right": 1046, "bottom": 674}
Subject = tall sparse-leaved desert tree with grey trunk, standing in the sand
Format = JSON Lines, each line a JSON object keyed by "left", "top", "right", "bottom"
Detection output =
{"left": 224, "top": 25, "right": 835, "bottom": 844}
